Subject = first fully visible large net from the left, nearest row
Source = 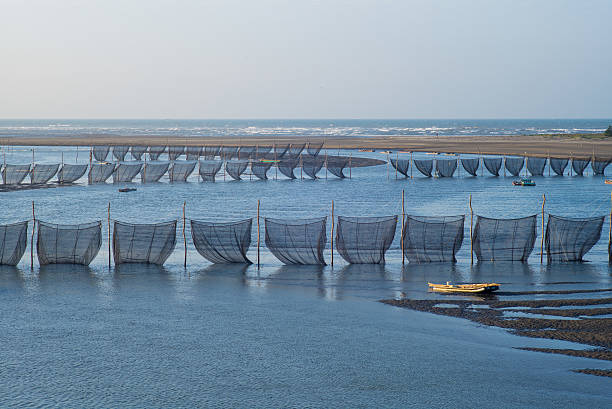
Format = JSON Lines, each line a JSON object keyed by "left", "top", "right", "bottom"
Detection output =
{"left": 36, "top": 221, "right": 102, "bottom": 266}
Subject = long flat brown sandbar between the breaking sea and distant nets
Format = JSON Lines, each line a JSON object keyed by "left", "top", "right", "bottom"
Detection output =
{"left": 1, "top": 134, "right": 612, "bottom": 158}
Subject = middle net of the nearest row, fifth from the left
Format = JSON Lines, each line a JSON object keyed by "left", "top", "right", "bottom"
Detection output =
{"left": 265, "top": 217, "right": 327, "bottom": 265}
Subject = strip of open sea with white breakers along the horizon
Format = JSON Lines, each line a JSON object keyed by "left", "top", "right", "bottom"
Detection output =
{"left": 0, "top": 118, "right": 612, "bottom": 138}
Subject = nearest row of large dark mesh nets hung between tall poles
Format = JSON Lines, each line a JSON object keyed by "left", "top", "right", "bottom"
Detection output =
{"left": 0, "top": 215, "right": 610, "bottom": 265}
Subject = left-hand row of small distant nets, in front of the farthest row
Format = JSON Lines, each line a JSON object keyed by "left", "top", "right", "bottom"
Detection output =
{"left": 2, "top": 156, "right": 351, "bottom": 185}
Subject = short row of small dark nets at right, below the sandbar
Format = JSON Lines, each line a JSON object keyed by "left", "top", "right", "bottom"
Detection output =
{"left": 389, "top": 156, "right": 612, "bottom": 177}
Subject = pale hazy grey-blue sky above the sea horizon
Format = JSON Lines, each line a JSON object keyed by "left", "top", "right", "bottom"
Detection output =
{"left": 0, "top": 0, "right": 612, "bottom": 118}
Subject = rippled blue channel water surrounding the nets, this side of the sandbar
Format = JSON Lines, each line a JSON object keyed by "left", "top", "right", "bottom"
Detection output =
{"left": 0, "top": 147, "right": 612, "bottom": 408}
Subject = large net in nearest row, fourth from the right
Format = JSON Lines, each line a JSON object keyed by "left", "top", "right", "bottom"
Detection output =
{"left": 336, "top": 216, "right": 397, "bottom": 264}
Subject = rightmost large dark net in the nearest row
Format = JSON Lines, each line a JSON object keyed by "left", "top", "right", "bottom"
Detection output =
{"left": 545, "top": 214, "right": 605, "bottom": 263}
